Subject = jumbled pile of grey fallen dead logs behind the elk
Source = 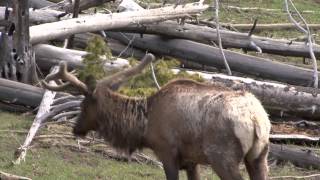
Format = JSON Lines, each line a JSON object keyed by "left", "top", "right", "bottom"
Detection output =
{"left": 0, "top": 0, "right": 320, "bottom": 172}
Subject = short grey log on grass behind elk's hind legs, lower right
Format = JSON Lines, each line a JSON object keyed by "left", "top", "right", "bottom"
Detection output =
{"left": 269, "top": 144, "right": 320, "bottom": 169}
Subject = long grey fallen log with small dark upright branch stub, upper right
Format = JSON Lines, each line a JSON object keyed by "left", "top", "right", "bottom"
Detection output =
{"left": 113, "top": 21, "right": 320, "bottom": 57}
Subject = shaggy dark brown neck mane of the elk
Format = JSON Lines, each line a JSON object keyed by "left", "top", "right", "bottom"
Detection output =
{"left": 95, "top": 87, "right": 148, "bottom": 153}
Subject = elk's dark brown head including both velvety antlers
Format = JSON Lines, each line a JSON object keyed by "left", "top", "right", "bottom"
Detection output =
{"left": 42, "top": 53, "right": 155, "bottom": 136}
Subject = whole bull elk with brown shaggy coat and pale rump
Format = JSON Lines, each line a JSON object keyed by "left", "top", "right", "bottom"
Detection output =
{"left": 43, "top": 54, "right": 270, "bottom": 180}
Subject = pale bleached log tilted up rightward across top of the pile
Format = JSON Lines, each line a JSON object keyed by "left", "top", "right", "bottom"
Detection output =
{"left": 30, "top": 3, "right": 208, "bottom": 44}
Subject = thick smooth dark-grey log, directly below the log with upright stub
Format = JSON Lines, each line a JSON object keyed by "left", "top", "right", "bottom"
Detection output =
{"left": 107, "top": 32, "right": 320, "bottom": 86}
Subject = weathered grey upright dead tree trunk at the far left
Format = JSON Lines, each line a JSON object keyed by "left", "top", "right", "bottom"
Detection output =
{"left": 0, "top": 0, "right": 37, "bottom": 84}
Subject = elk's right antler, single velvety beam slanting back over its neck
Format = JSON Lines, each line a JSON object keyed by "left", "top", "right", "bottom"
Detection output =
{"left": 99, "top": 53, "right": 155, "bottom": 89}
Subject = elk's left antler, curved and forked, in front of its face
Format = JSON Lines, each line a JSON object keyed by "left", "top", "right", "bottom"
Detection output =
{"left": 41, "top": 61, "right": 88, "bottom": 94}
